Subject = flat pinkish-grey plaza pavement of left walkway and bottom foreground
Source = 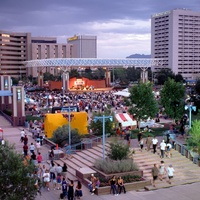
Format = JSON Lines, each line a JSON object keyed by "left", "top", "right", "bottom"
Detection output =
{"left": 0, "top": 116, "right": 200, "bottom": 200}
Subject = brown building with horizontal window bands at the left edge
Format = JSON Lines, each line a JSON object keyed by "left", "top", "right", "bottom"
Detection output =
{"left": 0, "top": 31, "right": 31, "bottom": 77}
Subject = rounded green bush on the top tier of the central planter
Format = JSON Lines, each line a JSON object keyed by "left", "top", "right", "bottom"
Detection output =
{"left": 108, "top": 142, "right": 130, "bottom": 160}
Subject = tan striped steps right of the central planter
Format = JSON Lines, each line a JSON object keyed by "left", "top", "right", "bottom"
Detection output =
{"left": 133, "top": 148, "right": 200, "bottom": 190}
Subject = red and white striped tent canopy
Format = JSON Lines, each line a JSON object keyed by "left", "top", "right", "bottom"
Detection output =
{"left": 115, "top": 113, "right": 137, "bottom": 127}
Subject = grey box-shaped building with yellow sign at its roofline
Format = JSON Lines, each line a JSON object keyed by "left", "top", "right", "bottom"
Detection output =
{"left": 67, "top": 35, "right": 97, "bottom": 58}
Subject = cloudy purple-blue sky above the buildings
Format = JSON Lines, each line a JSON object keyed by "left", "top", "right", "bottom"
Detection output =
{"left": 0, "top": 0, "right": 200, "bottom": 58}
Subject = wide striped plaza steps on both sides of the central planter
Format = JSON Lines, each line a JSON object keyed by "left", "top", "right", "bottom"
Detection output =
{"left": 49, "top": 141, "right": 200, "bottom": 190}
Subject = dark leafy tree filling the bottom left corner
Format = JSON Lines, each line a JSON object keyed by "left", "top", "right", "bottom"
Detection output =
{"left": 0, "top": 141, "right": 37, "bottom": 200}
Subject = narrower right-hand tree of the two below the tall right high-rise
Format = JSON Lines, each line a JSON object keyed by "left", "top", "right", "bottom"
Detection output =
{"left": 160, "top": 78, "right": 185, "bottom": 120}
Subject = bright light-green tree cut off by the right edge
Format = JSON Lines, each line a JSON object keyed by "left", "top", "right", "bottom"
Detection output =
{"left": 187, "top": 120, "right": 200, "bottom": 155}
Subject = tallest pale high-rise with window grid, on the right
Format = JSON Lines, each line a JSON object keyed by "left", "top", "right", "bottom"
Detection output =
{"left": 151, "top": 9, "right": 200, "bottom": 79}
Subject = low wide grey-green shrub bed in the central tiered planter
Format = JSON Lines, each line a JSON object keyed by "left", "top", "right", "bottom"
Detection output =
{"left": 94, "top": 158, "right": 138, "bottom": 174}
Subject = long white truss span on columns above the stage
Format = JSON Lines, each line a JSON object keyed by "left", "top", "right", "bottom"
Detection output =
{"left": 24, "top": 58, "right": 162, "bottom": 90}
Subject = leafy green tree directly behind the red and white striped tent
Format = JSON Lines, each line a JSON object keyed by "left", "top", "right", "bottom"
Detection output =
{"left": 126, "top": 83, "right": 158, "bottom": 121}
